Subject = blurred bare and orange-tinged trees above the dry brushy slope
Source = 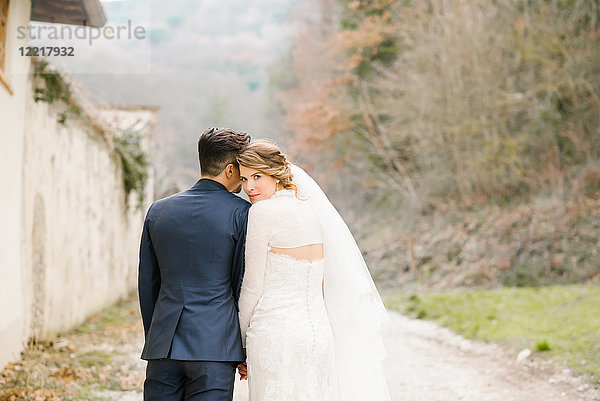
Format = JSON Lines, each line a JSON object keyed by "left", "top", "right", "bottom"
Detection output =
{"left": 282, "top": 0, "right": 600, "bottom": 208}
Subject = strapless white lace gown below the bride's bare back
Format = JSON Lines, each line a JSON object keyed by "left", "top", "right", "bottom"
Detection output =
{"left": 246, "top": 252, "right": 335, "bottom": 401}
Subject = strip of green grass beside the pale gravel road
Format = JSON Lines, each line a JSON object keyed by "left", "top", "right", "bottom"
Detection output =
{"left": 383, "top": 285, "right": 600, "bottom": 379}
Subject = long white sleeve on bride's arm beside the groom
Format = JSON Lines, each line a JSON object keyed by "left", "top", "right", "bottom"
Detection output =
{"left": 239, "top": 201, "right": 270, "bottom": 348}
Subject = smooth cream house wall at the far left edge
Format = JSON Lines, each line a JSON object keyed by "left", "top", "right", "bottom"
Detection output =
{"left": 0, "top": 0, "right": 31, "bottom": 369}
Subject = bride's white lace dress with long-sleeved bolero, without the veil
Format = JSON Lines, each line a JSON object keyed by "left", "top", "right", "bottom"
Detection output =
{"left": 239, "top": 190, "right": 336, "bottom": 401}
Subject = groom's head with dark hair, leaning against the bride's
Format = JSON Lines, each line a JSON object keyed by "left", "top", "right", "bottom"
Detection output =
{"left": 198, "top": 128, "right": 250, "bottom": 192}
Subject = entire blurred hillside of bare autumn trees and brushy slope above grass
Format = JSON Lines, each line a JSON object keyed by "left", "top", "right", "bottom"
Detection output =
{"left": 280, "top": 0, "right": 600, "bottom": 287}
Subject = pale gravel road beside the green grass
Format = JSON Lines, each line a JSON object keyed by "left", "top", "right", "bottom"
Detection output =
{"left": 234, "top": 312, "right": 600, "bottom": 401}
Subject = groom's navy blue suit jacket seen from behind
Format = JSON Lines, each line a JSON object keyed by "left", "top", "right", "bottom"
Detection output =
{"left": 138, "top": 179, "right": 250, "bottom": 362}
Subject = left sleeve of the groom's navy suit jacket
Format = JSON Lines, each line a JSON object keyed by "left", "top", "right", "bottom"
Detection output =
{"left": 138, "top": 206, "right": 160, "bottom": 336}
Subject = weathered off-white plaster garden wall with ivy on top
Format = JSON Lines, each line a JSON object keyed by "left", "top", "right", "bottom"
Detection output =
{"left": 22, "top": 81, "right": 152, "bottom": 338}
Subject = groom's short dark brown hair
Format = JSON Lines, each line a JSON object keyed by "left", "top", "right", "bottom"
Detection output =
{"left": 198, "top": 127, "right": 250, "bottom": 177}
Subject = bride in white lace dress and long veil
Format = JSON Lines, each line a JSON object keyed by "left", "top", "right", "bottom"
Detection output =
{"left": 238, "top": 141, "right": 390, "bottom": 401}
